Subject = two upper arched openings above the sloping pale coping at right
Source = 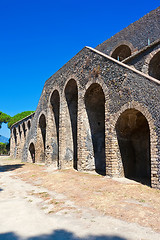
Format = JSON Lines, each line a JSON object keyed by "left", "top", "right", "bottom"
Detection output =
{"left": 111, "top": 44, "right": 160, "bottom": 80}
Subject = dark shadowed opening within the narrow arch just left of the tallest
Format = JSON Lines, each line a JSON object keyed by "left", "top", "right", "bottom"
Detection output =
{"left": 50, "top": 90, "right": 60, "bottom": 167}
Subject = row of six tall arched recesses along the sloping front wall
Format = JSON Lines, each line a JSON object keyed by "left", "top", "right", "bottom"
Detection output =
{"left": 29, "top": 79, "right": 151, "bottom": 184}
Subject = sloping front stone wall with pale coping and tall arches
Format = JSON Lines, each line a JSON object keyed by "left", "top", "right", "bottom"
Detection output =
{"left": 18, "top": 47, "right": 160, "bottom": 188}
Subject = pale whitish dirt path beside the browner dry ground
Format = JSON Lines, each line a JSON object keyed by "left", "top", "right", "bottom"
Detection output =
{"left": 0, "top": 157, "right": 160, "bottom": 240}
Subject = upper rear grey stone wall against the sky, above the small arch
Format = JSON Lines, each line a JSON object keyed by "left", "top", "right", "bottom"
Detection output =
{"left": 96, "top": 7, "right": 160, "bottom": 56}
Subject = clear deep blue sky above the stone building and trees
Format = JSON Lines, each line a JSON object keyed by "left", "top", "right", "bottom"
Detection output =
{"left": 0, "top": 0, "right": 159, "bottom": 136}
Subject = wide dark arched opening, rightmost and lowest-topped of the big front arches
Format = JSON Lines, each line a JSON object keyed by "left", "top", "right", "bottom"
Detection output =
{"left": 116, "top": 109, "right": 151, "bottom": 185}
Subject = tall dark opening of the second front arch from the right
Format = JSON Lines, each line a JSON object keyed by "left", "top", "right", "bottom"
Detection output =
{"left": 85, "top": 83, "right": 106, "bottom": 175}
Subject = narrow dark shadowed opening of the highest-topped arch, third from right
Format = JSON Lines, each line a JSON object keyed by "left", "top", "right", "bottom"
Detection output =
{"left": 65, "top": 79, "right": 78, "bottom": 169}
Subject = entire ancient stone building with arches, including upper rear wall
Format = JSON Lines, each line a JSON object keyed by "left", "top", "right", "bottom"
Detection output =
{"left": 11, "top": 7, "right": 160, "bottom": 189}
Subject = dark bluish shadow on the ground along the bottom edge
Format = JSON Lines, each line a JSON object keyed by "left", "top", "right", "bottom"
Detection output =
{"left": 0, "top": 229, "right": 126, "bottom": 240}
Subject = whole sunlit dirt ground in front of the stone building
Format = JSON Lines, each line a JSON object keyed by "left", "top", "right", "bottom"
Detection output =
{"left": 0, "top": 157, "right": 160, "bottom": 240}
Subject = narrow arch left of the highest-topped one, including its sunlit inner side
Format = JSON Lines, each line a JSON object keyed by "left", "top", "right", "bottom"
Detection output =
{"left": 50, "top": 90, "right": 60, "bottom": 167}
